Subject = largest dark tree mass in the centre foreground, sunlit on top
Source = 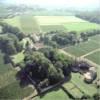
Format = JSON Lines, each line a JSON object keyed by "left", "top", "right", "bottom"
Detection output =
{"left": 24, "top": 52, "right": 64, "bottom": 84}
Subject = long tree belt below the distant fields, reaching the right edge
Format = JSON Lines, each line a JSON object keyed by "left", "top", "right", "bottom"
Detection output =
{"left": 41, "top": 30, "right": 100, "bottom": 48}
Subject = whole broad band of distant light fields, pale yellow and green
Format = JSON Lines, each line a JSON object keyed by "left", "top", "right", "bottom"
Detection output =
{"left": 3, "top": 15, "right": 100, "bottom": 33}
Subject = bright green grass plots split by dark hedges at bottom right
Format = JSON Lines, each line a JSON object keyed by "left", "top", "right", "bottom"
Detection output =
{"left": 33, "top": 73, "right": 98, "bottom": 100}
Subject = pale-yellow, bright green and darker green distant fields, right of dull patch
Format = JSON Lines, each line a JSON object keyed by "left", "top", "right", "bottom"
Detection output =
{"left": 35, "top": 16, "right": 100, "bottom": 32}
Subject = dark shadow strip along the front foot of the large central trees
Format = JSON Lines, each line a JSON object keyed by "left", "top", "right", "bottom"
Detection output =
{"left": 16, "top": 66, "right": 71, "bottom": 98}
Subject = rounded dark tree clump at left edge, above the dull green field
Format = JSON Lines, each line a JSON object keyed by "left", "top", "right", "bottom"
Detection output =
{"left": 0, "top": 33, "right": 22, "bottom": 55}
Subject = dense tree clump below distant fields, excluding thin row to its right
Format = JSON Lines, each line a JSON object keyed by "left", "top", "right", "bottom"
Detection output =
{"left": 42, "top": 31, "right": 78, "bottom": 47}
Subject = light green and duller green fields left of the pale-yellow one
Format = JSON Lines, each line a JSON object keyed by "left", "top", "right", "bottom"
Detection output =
{"left": 3, "top": 15, "right": 40, "bottom": 34}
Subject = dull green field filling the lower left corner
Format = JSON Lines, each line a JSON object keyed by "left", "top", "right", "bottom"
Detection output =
{"left": 0, "top": 52, "right": 33, "bottom": 99}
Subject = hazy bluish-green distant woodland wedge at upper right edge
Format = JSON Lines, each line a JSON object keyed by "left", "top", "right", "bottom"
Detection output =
{"left": 76, "top": 11, "right": 100, "bottom": 24}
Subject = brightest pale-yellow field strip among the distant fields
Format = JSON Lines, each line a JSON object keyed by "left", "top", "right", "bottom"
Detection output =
{"left": 35, "top": 16, "right": 86, "bottom": 25}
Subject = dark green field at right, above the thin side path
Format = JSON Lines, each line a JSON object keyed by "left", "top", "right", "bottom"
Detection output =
{"left": 65, "top": 35, "right": 100, "bottom": 57}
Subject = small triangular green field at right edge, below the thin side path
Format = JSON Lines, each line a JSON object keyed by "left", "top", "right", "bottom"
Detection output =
{"left": 86, "top": 51, "right": 100, "bottom": 65}
